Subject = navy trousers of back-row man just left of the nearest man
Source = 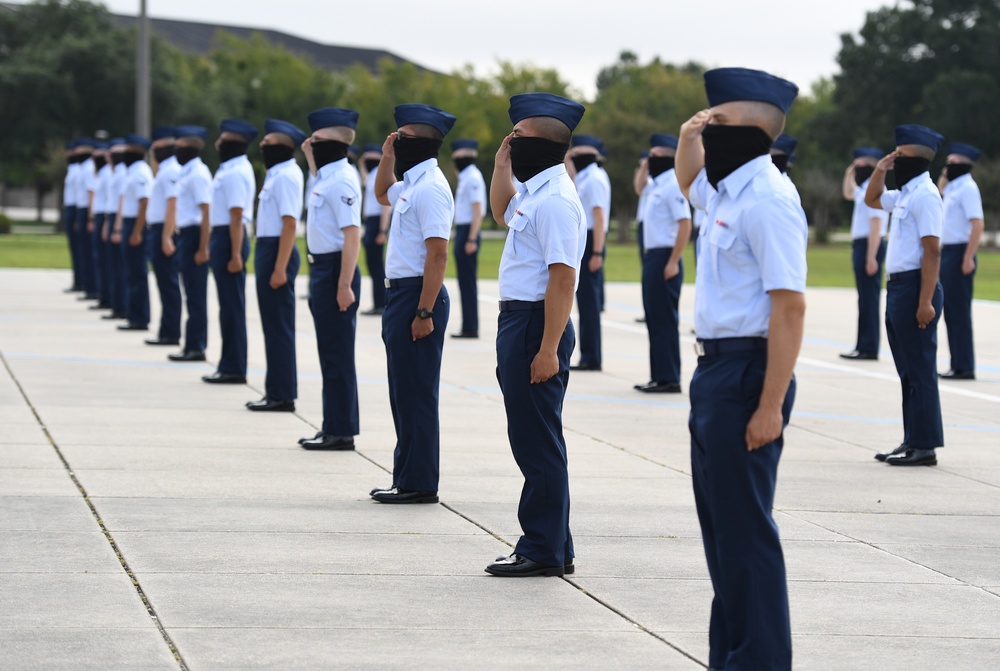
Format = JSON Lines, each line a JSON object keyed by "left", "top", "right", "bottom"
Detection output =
{"left": 642, "top": 247, "right": 684, "bottom": 382}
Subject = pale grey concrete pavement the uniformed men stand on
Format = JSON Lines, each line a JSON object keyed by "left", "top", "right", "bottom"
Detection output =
{"left": 0, "top": 270, "right": 1000, "bottom": 671}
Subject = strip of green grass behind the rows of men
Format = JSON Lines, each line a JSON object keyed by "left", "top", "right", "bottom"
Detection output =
{"left": 0, "top": 234, "right": 1000, "bottom": 301}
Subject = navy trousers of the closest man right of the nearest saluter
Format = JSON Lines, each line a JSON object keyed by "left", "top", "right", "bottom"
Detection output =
{"left": 885, "top": 270, "right": 944, "bottom": 449}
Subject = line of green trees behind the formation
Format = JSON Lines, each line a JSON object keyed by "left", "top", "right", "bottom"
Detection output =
{"left": 0, "top": 0, "right": 1000, "bottom": 239}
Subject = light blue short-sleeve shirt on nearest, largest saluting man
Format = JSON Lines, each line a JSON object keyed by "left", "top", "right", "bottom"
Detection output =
{"left": 689, "top": 155, "right": 809, "bottom": 339}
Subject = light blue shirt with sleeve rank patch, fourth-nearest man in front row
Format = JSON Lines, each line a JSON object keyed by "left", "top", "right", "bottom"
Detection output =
{"left": 306, "top": 158, "right": 361, "bottom": 254}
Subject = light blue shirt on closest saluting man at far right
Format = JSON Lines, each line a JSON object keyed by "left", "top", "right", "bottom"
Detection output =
{"left": 881, "top": 172, "right": 944, "bottom": 275}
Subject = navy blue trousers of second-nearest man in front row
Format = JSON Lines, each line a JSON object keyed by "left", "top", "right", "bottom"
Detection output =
{"left": 497, "top": 308, "right": 576, "bottom": 566}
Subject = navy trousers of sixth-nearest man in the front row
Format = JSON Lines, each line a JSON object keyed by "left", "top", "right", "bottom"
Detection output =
{"left": 208, "top": 226, "right": 250, "bottom": 375}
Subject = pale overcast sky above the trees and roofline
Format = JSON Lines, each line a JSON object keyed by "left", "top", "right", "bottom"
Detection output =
{"left": 47, "top": 0, "right": 896, "bottom": 97}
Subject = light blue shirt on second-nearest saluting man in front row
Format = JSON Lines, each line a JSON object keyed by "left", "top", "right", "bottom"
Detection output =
{"left": 499, "top": 164, "right": 587, "bottom": 301}
